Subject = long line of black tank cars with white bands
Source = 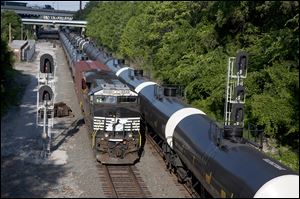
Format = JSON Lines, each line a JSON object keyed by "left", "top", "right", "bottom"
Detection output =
{"left": 65, "top": 30, "right": 299, "bottom": 198}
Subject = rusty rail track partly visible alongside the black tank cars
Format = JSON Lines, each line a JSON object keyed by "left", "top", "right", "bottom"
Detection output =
{"left": 146, "top": 132, "right": 200, "bottom": 198}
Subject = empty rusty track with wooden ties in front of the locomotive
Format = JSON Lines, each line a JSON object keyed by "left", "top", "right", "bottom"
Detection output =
{"left": 99, "top": 165, "right": 151, "bottom": 198}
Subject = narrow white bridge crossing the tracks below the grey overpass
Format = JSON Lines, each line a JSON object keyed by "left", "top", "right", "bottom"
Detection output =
{"left": 21, "top": 19, "right": 87, "bottom": 28}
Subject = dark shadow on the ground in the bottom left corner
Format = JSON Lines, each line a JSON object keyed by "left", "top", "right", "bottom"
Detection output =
{"left": 1, "top": 156, "right": 66, "bottom": 198}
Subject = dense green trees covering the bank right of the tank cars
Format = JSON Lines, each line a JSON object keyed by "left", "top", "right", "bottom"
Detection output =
{"left": 87, "top": 1, "right": 299, "bottom": 159}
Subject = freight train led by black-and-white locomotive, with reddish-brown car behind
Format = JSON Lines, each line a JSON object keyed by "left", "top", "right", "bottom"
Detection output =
{"left": 59, "top": 30, "right": 144, "bottom": 164}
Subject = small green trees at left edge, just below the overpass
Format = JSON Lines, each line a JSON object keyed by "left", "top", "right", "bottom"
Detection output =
{"left": 1, "top": 11, "right": 21, "bottom": 41}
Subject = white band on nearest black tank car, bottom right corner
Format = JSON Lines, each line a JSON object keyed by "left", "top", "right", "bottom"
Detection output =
{"left": 254, "top": 175, "right": 299, "bottom": 198}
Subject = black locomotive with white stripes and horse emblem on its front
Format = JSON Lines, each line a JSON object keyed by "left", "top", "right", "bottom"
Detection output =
{"left": 87, "top": 71, "right": 141, "bottom": 164}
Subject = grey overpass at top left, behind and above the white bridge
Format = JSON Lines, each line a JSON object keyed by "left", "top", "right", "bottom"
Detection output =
{"left": 1, "top": 5, "right": 75, "bottom": 20}
